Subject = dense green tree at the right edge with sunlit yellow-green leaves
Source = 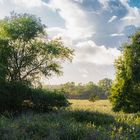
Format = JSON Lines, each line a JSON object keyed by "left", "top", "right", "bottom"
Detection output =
{"left": 110, "top": 31, "right": 140, "bottom": 112}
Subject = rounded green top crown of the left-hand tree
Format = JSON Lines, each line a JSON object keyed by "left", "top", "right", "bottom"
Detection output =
{"left": 0, "top": 12, "right": 45, "bottom": 41}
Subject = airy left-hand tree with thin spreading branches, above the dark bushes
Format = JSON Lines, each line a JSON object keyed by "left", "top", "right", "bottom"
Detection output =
{"left": 0, "top": 13, "right": 73, "bottom": 83}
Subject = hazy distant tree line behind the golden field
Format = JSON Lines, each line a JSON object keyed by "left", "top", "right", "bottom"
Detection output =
{"left": 44, "top": 78, "right": 112, "bottom": 99}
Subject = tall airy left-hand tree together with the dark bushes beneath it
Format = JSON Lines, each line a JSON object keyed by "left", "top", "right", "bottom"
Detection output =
{"left": 0, "top": 13, "right": 73, "bottom": 112}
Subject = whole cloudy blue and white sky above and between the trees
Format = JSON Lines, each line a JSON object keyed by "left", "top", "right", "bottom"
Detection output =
{"left": 0, "top": 0, "right": 140, "bottom": 84}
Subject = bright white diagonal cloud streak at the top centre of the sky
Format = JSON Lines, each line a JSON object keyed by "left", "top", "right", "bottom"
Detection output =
{"left": 49, "top": 0, "right": 94, "bottom": 40}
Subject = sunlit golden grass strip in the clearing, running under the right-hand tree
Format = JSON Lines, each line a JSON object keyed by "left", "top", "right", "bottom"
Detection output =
{"left": 69, "top": 100, "right": 140, "bottom": 125}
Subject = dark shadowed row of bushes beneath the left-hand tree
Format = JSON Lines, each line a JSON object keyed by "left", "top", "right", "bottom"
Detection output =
{"left": 0, "top": 83, "right": 69, "bottom": 112}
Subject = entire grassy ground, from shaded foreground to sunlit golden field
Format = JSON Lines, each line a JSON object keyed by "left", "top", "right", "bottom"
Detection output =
{"left": 0, "top": 100, "right": 140, "bottom": 140}
